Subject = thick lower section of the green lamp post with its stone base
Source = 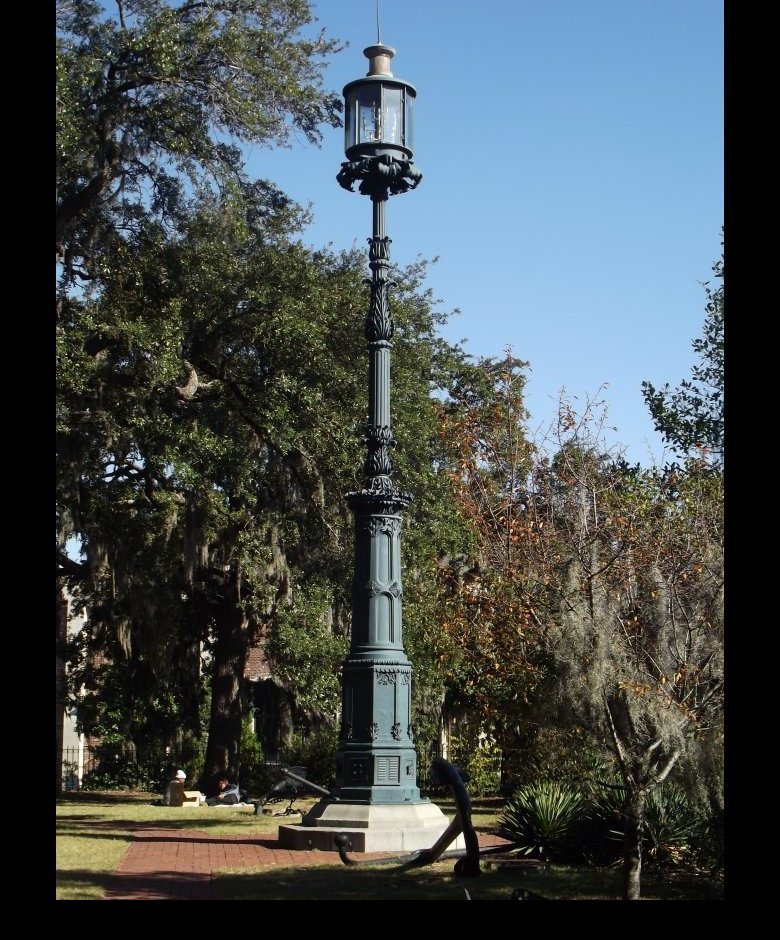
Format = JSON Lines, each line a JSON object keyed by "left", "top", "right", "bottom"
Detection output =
{"left": 279, "top": 482, "right": 454, "bottom": 852}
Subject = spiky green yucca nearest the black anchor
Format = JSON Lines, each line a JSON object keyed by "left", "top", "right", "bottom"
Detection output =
{"left": 499, "top": 780, "right": 585, "bottom": 861}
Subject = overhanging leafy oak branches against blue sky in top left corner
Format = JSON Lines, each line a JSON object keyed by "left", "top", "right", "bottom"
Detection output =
{"left": 56, "top": 0, "right": 341, "bottom": 280}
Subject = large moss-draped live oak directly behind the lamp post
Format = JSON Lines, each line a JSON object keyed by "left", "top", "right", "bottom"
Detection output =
{"left": 62, "top": 184, "right": 476, "bottom": 773}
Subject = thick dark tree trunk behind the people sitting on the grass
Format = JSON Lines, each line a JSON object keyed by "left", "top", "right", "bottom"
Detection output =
{"left": 200, "top": 589, "right": 248, "bottom": 796}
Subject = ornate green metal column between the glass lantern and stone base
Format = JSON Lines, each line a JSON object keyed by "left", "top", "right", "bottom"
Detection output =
{"left": 333, "top": 189, "right": 420, "bottom": 804}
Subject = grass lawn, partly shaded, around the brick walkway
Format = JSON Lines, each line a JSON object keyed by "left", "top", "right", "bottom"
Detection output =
{"left": 56, "top": 792, "right": 723, "bottom": 901}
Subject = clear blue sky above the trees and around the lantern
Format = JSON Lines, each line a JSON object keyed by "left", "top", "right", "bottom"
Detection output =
{"left": 248, "top": 0, "right": 724, "bottom": 464}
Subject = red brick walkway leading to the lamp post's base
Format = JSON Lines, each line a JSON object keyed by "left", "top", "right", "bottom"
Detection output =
{"left": 105, "top": 827, "right": 503, "bottom": 901}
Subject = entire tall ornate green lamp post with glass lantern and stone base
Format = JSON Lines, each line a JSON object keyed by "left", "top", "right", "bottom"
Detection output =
{"left": 279, "top": 43, "right": 448, "bottom": 852}
